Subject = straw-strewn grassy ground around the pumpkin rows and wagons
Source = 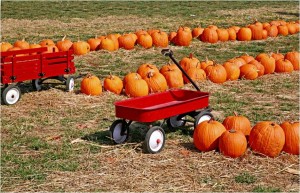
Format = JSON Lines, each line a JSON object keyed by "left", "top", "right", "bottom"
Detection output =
{"left": 1, "top": 1, "right": 299, "bottom": 192}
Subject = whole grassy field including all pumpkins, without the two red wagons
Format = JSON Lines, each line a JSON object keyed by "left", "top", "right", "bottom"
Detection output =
{"left": 1, "top": 1, "right": 300, "bottom": 192}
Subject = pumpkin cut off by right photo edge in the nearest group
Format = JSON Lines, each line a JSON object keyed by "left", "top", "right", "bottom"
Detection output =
{"left": 280, "top": 121, "right": 300, "bottom": 155}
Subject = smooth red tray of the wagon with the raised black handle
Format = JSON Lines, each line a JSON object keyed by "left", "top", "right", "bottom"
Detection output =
{"left": 115, "top": 90, "right": 209, "bottom": 122}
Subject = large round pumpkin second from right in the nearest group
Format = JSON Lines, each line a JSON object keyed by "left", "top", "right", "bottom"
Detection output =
{"left": 249, "top": 121, "right": 285, "bottom": 157}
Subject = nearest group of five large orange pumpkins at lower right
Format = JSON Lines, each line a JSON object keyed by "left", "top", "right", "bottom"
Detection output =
{"left": 193, "top": 113, "right": 300, "bottom": 158}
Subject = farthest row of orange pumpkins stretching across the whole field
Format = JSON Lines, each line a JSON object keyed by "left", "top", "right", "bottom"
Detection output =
{"left": 1, "top": 20, "right": 300, "bottom": 55}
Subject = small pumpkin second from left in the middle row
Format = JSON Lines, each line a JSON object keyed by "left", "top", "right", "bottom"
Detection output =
{"left": 103, "top": 75, "right": 123, "bottom": 95}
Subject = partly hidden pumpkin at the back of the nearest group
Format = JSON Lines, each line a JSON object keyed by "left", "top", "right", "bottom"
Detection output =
{"left": 222, "top": 112, "right": 251, "bottom": 135}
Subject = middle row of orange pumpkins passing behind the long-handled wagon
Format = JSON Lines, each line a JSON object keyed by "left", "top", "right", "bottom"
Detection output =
{"left": 81, "top": 51, "right": 300, "bottom": 97}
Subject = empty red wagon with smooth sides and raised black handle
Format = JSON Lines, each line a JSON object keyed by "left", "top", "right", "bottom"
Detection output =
{"left": 110, "top": 49, "right": 213, "bottom": 153}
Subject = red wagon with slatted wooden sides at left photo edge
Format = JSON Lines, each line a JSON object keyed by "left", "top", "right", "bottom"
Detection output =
{"left": 0, "top": 47, "right": 76, "bottom": 105}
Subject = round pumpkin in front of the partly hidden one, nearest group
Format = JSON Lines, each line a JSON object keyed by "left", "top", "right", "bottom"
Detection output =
{"left": 219, "top": 129, "right": 247, "bottom": 158}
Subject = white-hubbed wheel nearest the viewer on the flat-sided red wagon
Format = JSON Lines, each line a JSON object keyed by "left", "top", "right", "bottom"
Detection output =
{"left": 144, "top": 126, "right": 166, "bottom": 154}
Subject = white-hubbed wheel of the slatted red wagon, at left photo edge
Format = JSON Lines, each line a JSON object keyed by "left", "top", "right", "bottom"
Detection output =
{"left": 1, "top": 84, "right": 21, "bottom": 105}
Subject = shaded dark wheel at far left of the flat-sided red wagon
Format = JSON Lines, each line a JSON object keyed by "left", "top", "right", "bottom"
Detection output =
{"left": 109, "top": 119, "right": 129, "bottom": 144}
